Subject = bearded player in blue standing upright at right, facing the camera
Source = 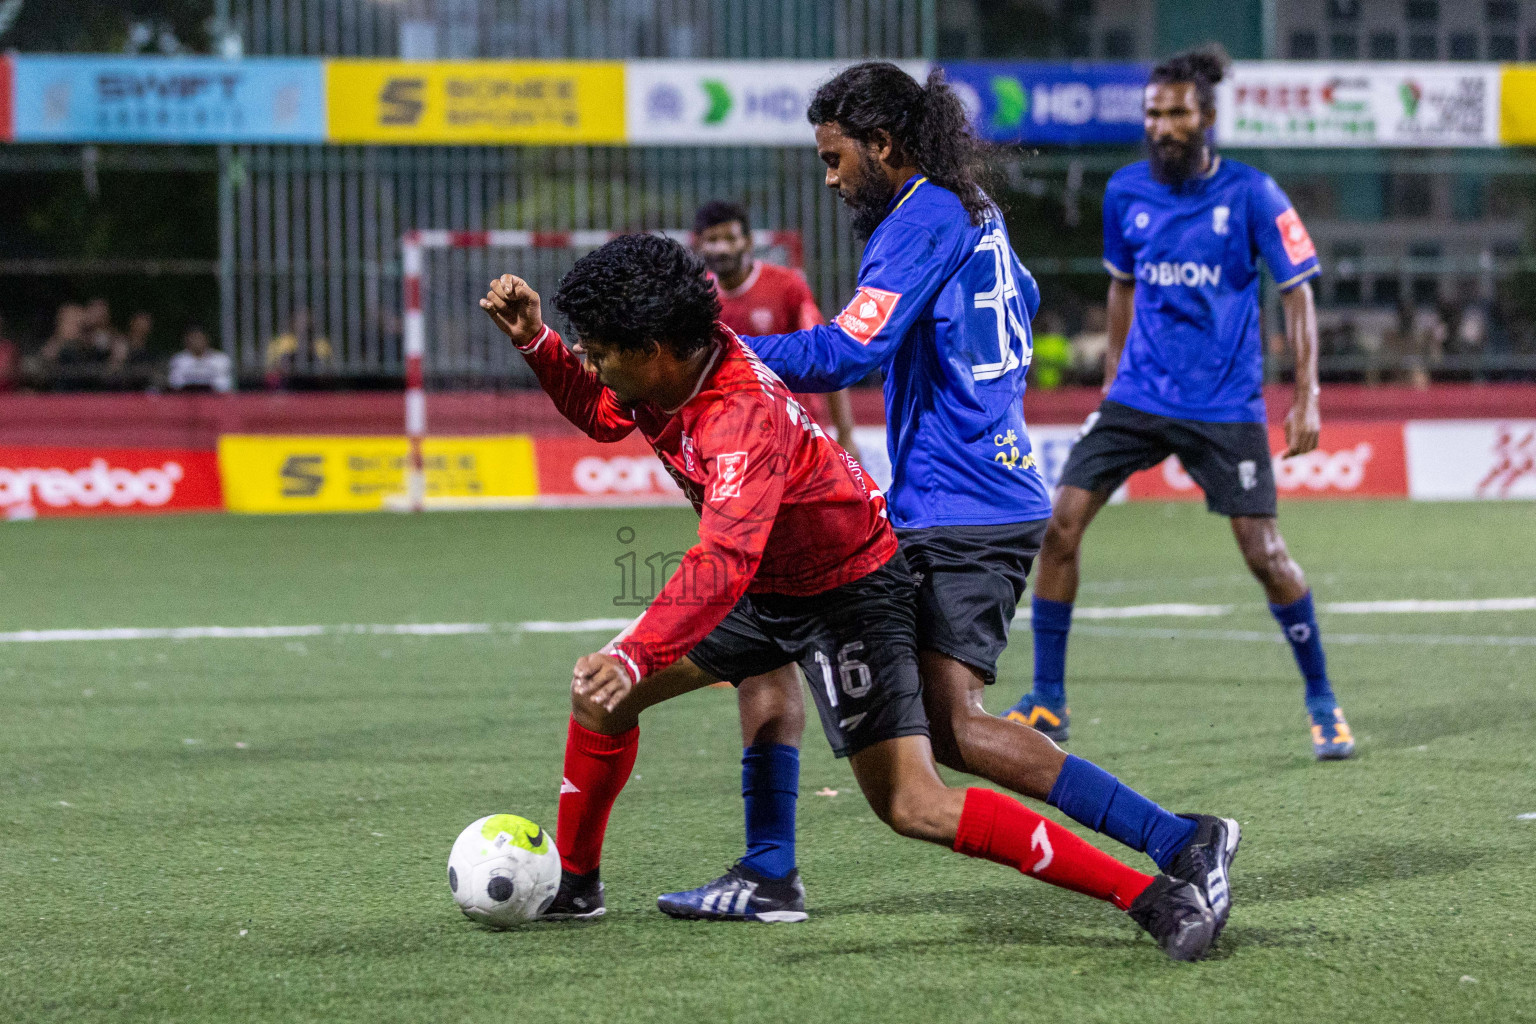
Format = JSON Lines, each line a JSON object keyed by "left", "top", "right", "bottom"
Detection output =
{"left": 1009, "top": 49, "right": 1355, "bottom": 760}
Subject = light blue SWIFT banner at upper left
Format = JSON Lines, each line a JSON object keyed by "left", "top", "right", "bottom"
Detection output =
{"left": 11, "top": 55, "right": 326, "bottom": 143}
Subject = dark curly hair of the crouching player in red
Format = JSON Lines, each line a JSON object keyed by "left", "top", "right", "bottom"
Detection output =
{"left": 554, "top": 235, "right": 720, "bottom": 359}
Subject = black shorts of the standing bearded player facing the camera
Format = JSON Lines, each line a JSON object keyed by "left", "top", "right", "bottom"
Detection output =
{"left": 1061, "top": 401, "right": 1276, "bottom": 516}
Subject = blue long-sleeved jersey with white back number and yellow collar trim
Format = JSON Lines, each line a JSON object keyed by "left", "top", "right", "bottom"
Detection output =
{"left": 746, "top": 178, "right": 1051, "bottom": 527}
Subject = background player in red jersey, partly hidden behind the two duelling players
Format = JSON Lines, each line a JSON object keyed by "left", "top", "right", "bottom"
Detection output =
{"left": 693, "top": 200, "right": 859, "bottom": 459}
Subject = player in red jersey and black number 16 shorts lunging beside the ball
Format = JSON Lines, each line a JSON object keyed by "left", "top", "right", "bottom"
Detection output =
{"left": 481, "top": 235, "right": 1215, "bottom": 960}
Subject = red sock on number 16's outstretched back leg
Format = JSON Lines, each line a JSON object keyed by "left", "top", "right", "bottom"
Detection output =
{"left": 954, "top": 788, "right": 1152, "bottom": 910}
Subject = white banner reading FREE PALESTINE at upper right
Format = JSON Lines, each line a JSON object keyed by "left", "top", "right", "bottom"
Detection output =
{"left": 1217, "top": 61, "right": 1499, "bottom": 147}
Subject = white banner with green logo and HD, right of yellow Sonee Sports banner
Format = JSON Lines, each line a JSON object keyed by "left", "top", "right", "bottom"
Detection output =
{"left": 624, "top": 60, "right": 929, "bottom": 146}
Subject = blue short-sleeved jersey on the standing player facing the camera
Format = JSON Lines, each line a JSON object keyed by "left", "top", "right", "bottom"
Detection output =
{"left": 1104, "top": 157, "right": 1318, "bottom": 422}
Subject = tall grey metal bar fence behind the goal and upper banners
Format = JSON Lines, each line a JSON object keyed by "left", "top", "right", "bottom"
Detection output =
{"left": 220, "top": 0, "right": 934, "bottom": 385}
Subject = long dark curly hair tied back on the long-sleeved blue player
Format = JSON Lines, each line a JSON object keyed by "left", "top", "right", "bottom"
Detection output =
{"left": 805, "top": 60, "right": 997, "bottom": 224}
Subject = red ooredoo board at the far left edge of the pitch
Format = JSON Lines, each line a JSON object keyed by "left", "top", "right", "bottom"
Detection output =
{"left": 0, "top": 445, "right": 223, "bottom": 519}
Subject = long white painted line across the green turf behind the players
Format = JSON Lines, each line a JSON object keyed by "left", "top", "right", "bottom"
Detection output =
{"left": 0, "top": 597, "right": 1536, "bottom": 646}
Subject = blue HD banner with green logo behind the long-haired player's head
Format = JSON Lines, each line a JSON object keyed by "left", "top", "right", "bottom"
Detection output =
{"left": 945, "top": 61, "right": 1147, "bottom": 144}
